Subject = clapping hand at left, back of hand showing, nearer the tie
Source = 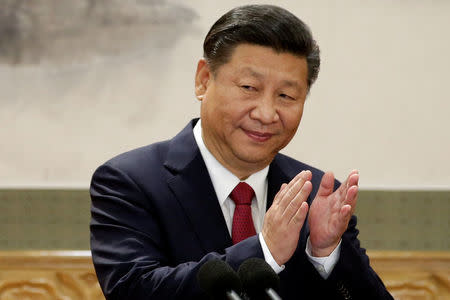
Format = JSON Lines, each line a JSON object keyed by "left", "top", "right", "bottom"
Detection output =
{"left": 262, "top": 171, "right": 312, "bottom": 265}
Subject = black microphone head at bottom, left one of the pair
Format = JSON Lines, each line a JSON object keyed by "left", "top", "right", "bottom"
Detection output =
{"left": 197, "top": 259, "right": 242, "bottom": 300}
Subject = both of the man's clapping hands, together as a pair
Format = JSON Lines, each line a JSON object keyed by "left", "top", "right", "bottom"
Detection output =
{"left": 262, "top": 170, "right": 359, "bottom": 265}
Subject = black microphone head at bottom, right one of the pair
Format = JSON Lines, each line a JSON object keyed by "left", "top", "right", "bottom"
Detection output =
{"left": 238, "top": 257, "right": 281, "bottom": 300}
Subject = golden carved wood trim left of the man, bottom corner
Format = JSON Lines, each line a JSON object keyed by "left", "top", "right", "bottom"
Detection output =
{"left": 0, "top": 251, "right": 105, "bottom": 300}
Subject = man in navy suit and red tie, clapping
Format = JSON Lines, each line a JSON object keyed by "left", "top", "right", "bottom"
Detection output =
{"left": 91, "top": 5, "right": 392, "bottom": 299}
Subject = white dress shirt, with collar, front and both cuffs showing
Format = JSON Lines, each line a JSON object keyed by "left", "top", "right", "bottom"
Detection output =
{"left": 194, "top": 120, "right": 340, "bottom": 279}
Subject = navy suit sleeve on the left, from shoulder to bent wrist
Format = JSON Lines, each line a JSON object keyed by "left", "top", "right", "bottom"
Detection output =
{"left": 90, "top": 164, "right": 263, "bottom": 300}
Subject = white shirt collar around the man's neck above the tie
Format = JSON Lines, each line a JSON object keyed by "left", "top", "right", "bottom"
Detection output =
{"left": 193, "top": 120, "right": 269, "bottom": 207}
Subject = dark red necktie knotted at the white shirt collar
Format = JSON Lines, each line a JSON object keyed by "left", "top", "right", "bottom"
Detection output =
{"left": 230, "top": 182, "right": 256, "bottom": 245}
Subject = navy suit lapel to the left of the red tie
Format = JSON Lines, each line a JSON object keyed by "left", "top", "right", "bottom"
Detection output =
{"left": 164, "top": 120, "right": 232, "bottom": 253}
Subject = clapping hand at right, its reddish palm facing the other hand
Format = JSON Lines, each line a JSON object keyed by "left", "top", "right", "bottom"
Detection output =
{"left": 308, "top": 170, "right": 359, "bottom": 257}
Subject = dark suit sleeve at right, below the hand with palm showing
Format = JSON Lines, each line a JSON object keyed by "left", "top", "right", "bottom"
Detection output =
{"left": 280, "top": 216, "right": 393, "bottom": 300}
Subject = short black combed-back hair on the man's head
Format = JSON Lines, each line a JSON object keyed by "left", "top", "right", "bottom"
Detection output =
{"left": 203, "top": 5, "right": 320, "bottom": 89}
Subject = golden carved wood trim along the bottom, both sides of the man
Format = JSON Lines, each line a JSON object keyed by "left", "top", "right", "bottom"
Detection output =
{"left": 0, "top": 251, "right": 450, "bottom": 300}
